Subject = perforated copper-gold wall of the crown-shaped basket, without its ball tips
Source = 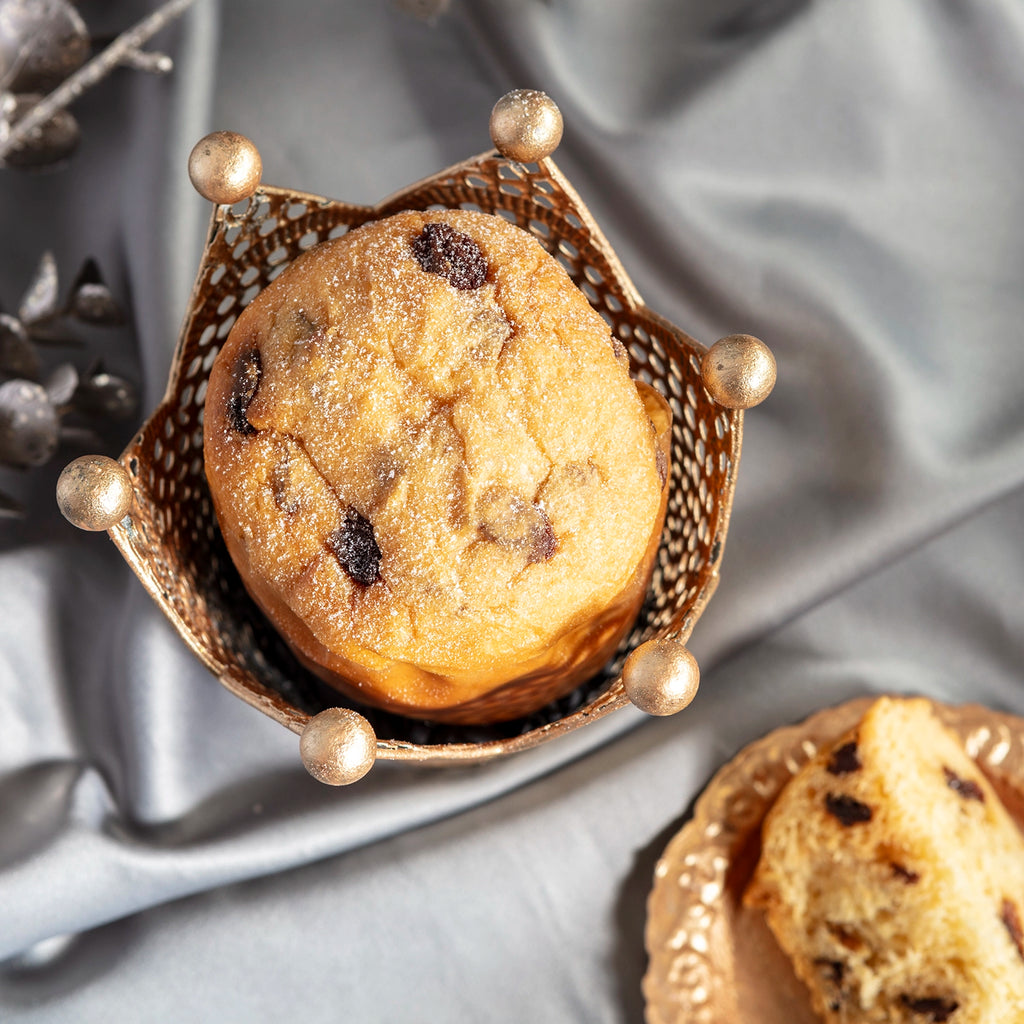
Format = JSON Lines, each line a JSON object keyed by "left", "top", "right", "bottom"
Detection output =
{"left": 110, "top": 153, "right": 742, "bottom": 763}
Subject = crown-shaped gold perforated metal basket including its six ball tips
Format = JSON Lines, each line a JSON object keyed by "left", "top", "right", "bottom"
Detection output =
{"left": 58, "top": 96, "right": 774, "bottom": 782}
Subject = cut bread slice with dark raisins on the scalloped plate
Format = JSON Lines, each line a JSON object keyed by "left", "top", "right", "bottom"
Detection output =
{"left": 744, "top": 697, "right": 1024, "bottom": 1024}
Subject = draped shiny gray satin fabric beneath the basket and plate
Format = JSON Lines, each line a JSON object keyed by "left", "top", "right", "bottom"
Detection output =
{"left": 0, "top": 0, "right": 1024, "bottom": 1022}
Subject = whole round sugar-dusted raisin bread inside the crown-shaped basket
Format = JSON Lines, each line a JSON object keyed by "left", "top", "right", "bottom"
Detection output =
{"left": 204, "top": 210, "right": 665, "bottom": 721}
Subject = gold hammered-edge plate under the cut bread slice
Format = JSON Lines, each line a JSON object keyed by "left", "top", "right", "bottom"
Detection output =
{"left": 643, "top": 697, "right": 1024, "bottom": 1024}
